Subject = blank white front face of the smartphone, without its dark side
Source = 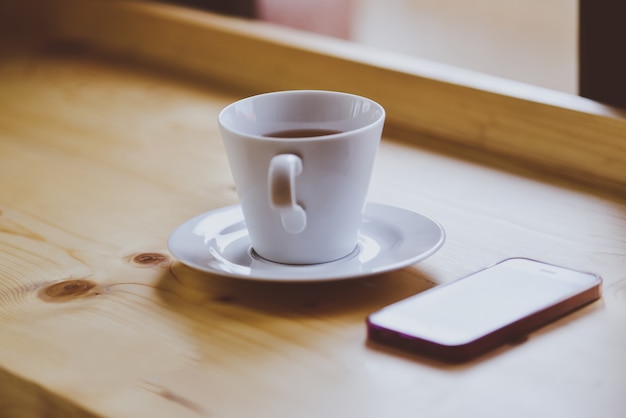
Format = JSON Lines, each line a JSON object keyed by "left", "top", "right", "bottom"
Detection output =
{"left": 370, "top": 258, "right": 598, "bottom": 346}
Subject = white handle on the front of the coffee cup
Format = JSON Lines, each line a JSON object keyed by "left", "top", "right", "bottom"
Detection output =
{"left": 268, "top": 154, "right": 306, "bottom": 234}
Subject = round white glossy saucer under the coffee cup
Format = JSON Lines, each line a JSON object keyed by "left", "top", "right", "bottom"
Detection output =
{"left": 168, "top": 203, "right": 445, "bottom": 282}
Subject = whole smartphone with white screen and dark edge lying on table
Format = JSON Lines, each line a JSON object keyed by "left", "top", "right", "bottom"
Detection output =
{"left": 367, "top": 258, "right": 602, "bottom": 362}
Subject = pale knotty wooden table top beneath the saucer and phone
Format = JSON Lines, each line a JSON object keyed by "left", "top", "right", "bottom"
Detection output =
{"left": 0, "top": 0, "right": 626, "bottom": 418}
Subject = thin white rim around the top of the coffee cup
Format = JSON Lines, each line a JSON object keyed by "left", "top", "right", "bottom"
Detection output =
{"left": 217, "top": 89, "right": 386, "bottom": 142}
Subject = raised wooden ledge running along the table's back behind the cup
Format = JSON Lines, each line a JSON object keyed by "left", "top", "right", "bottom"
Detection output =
{"left": 5, "top": 0, "right": 626, "bottom": 191}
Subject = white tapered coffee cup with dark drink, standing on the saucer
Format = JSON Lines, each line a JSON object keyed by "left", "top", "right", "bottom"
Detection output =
{"left": 218, "top": 90, "right": 385, "bottom": 264}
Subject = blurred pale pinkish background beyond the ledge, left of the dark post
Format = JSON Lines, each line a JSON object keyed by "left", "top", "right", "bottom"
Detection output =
{"left": 172, "top": 0, "right": 578, "bottom": 93}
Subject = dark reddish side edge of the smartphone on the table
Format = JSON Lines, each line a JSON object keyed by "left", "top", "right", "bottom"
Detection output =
{"left": 367, "top": 282, "right": 601, "bottom": 363}
